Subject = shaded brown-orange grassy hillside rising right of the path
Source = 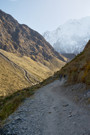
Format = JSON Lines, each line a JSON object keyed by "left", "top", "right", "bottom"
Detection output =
{"left": 60, "top": 40, "right": 90, "bottom": 85}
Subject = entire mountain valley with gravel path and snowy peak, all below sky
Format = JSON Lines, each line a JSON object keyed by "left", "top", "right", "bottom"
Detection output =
{"left": 0, "top": 10, "right": 90, "bottom": 135}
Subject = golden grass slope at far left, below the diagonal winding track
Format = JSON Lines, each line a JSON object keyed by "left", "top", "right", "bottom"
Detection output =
{"left": 0, "top": 53, "right": 29, "bottom": 96}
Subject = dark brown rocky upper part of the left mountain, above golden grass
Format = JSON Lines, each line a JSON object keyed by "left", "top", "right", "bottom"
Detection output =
{"left": 0, "top": 11, "right": 64, "bottom": 64}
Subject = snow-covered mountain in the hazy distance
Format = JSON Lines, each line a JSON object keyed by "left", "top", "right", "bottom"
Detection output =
{"left": 43, "top": 17, "right": 90, "bottom": 54}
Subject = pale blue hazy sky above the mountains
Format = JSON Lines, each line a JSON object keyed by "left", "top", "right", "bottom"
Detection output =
{"left": 0, "top": 0, "right": 90, "bottom": 33}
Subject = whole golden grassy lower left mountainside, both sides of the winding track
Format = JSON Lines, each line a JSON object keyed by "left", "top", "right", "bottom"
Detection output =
{"left": 0, "top": 49, "right": 64, "bottom": 96}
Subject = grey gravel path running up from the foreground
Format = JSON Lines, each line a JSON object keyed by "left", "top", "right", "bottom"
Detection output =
{"left": 0, "top": 81, "right": 90, "bottom": 135}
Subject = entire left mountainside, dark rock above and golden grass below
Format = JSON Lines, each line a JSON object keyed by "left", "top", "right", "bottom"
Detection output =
{"left": 0, "top": 10, "right": 67, "bottom": 96}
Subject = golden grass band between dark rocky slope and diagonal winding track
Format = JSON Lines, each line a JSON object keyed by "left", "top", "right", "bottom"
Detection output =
{"left": 0, "top": 49, "right": 65, "bottom": 75}
